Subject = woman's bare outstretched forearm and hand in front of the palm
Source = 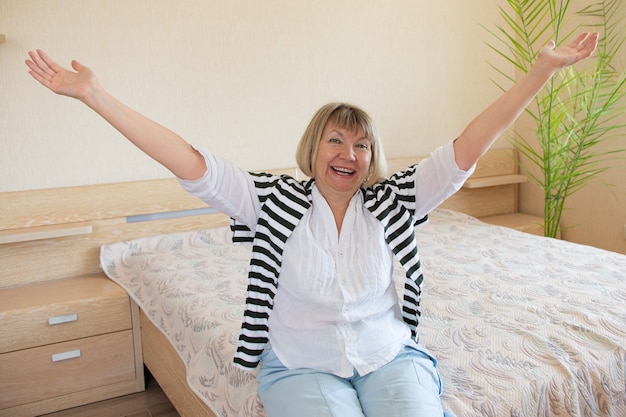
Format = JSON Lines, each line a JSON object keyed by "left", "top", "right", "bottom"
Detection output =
{"left": 454, "top": 32, "right": 598, "bottom": 170}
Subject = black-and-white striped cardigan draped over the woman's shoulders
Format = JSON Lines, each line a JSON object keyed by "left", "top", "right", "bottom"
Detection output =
{"left": 231, "top": 166, "right": 427, "bottom": 370}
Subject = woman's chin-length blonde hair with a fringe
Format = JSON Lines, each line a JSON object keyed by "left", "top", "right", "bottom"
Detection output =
{"left": 296, "top": 103, "right": 387, "bottom": 187}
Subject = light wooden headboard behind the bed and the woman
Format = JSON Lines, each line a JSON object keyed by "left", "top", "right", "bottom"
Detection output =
{"left": 0, "top": 150, "right": 525, "bottom": 288}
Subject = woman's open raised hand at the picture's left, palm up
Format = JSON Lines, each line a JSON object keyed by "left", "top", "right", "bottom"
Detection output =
{"left": 26, "top": 49, "right": 98, "bottom": 101}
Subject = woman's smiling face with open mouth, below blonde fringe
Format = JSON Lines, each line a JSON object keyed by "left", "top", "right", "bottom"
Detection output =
{"left": 312, "top": 122, "right": 372, "bottom": 201}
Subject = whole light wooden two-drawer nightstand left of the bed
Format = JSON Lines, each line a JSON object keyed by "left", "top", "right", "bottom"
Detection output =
{"left": 0, "top": 275, "right": 144, "bottom": 417}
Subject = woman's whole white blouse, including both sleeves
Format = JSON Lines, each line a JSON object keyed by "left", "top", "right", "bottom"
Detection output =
{"left": 181, "top": 143, "right": 473, "bottom": 377}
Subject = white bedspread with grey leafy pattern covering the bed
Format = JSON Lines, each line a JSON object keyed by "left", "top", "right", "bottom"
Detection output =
{"left": 101, "top": 210, "right": 626, "bottom": 417}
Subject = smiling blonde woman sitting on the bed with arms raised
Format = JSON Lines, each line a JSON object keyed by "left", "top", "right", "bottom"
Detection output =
{"left": 26, "top": 33, "right": 598, "bottom": 417}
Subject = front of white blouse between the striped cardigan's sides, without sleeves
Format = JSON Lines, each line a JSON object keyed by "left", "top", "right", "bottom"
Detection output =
{"left": 269, "top": 188, "right": 404, "bottom": 377}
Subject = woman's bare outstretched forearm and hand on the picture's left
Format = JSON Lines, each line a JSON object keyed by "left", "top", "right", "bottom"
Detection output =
{"left": 26, "top": 50, "right": 207, "bottom": 180}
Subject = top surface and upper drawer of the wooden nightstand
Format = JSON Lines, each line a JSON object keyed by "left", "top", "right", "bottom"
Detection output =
{"left": 0, "top": 276, "right": 132, "bottom": 353}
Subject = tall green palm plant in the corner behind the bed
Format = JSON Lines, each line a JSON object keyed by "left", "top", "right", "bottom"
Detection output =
{"left": 483, "top": 0, "right": 626, "bottom": 237}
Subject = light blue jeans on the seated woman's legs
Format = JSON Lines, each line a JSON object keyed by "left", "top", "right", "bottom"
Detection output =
{"left": 257, "top": 346, "right": 450, "bottom": 417}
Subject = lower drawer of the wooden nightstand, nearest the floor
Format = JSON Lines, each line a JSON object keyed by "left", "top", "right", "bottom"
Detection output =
{"left": 0, "top": 330, "right": 136, "bottom": 408}
